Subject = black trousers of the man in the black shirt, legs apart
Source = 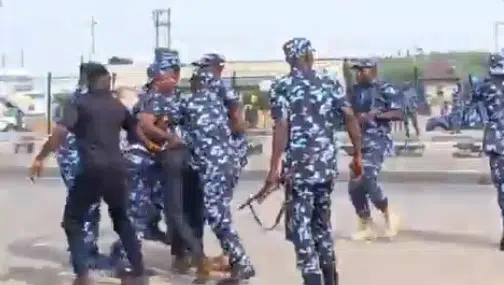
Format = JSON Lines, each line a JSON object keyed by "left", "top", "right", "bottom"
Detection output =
{"left": 62, "top": 165, "right": 144, "bottom": 276}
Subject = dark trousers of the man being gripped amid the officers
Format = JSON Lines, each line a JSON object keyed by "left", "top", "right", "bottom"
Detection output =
{"left": 158, "top": 148, "right": 204, "bottom": 259}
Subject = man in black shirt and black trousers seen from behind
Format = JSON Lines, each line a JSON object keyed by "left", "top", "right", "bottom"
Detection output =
{"left": 31, "top": 64, "right": 150, "bottom": 285}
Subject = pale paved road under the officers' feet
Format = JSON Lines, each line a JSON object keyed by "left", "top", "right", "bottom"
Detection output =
{"left": 0, "top": 177, "right": 504, "bottom": 285}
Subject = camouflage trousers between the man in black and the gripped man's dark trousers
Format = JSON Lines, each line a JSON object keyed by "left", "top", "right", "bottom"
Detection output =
{"left": 111, "top": 149, "right": 162, "bottom": 265}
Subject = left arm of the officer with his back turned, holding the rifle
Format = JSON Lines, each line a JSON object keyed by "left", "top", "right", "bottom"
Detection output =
{"left": 269, "top": 79, "right": 289, "bottom": 169}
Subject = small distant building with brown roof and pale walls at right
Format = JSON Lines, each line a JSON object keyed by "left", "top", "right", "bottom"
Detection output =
{"left": 420, "top": 60, "right": 459, "bottom": 103}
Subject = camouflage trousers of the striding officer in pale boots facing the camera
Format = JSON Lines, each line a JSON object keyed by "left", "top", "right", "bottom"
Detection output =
{"left": 348, "top": 144, "right": 388, "bottom": 219}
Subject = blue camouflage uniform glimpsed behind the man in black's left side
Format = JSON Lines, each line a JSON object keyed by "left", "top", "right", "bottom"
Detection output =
{"left": 54, "top": 88, "right": 100, "bottom": 261}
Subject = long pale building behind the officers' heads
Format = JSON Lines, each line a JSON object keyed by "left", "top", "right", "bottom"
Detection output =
{"left": 108, "top": 58, "right": 344, "bottom": 92}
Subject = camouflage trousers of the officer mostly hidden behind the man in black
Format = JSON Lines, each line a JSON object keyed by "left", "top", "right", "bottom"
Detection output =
{"left": 58, "top": 161, "right": 100, "bottom": 253}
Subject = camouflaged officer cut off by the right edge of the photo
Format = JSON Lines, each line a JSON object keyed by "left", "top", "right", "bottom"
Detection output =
{"left": 480, "top": 52, "right": 504, "bottom": 248}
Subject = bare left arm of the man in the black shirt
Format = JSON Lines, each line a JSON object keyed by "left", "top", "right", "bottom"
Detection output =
{"left": 36, "top": 100, "right": 79, "bottom": 160}
